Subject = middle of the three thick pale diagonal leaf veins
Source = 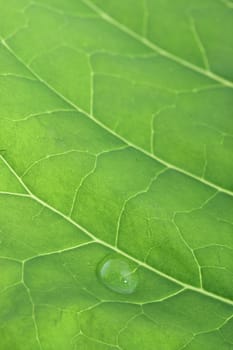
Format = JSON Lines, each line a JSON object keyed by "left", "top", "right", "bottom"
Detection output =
{"left": 2, "top": 40, "right": 233, "bottom": 197}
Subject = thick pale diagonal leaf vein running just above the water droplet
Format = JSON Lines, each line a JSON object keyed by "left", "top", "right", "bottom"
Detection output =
{"left": 0, "top": 155, "right": 233, "bottom": 305}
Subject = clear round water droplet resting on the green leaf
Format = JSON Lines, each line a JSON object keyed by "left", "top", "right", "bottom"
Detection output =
{"left": 97, "top": 256, "right": 138, "bottom": 294}
